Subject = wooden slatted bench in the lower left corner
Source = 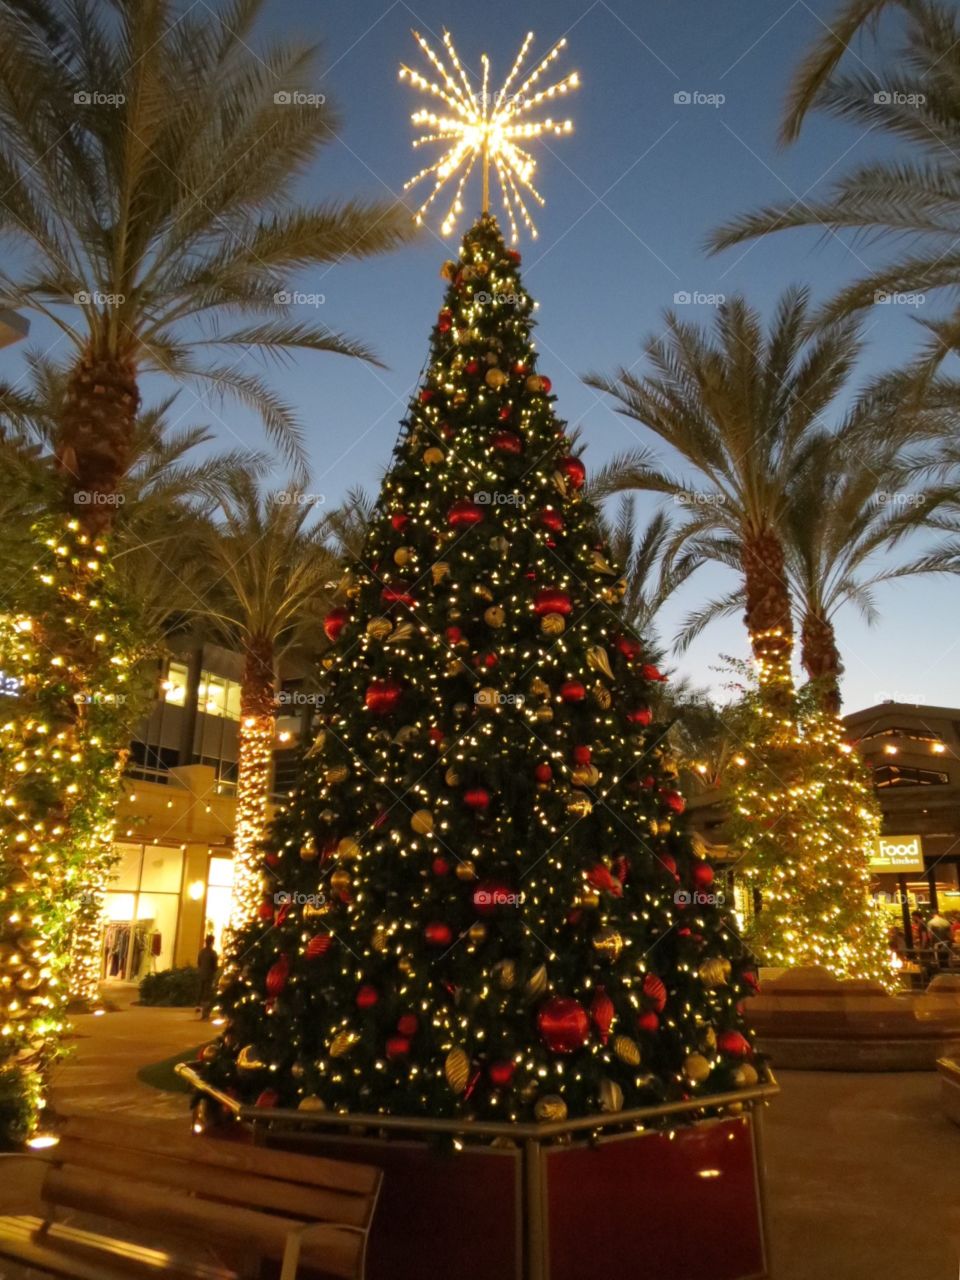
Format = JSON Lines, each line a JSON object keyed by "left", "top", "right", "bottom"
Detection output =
{"left": 0, "top": 1115, "right": 383, "bottom": 1280}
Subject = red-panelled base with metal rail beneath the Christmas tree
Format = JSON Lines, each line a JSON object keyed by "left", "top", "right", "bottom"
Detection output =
{"left": 178, "top": 1066, "right": 777, "bottom": 1280}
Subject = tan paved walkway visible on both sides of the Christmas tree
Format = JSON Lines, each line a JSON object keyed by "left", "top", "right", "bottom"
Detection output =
{"left": 26, "top": 988, "right": 960, "bottom": 1280}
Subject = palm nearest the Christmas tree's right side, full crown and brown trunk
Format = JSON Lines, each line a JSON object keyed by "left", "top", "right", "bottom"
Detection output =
{"left": 586, "top": 288, "right": 860, "bottom": 704}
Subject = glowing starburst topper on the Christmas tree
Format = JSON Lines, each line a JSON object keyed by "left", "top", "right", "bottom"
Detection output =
{"left": 399, "top": 31, "right": 580, "bottom": 241}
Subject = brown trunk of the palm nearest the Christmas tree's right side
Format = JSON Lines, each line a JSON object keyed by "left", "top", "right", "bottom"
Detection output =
{"left": 740, "top": 529, "right": 794, "bottom": 703}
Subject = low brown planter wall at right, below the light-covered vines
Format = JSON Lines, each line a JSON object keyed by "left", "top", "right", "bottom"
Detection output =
{"left": 750, "top": 968, "right": 960, "bottom": 1071}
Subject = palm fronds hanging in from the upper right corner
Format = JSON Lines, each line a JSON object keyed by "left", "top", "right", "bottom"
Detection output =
{"left": 709, "top": 0, "right": 960, "bottom": 335}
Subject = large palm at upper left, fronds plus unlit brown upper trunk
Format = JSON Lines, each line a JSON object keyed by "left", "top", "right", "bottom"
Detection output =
{"left": 0, "top": 0, "right": 411, "bottom": 522}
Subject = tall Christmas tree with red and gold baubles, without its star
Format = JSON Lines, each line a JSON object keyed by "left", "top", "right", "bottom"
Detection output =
{"left": 205, "top": 215, "right": 756, "bottom": 1120}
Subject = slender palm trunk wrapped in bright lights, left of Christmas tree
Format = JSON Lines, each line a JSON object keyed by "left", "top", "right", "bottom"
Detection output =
{"left": 230, "top": 637, "right": 276, "bottom": 931}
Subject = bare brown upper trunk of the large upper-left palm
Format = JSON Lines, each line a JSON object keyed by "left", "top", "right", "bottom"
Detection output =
{"left": 56, "top": 352, "right": 140, "bottom": 536}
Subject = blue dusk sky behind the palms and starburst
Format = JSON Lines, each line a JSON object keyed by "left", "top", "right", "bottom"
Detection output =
{"left": 0, "top": 0, "right": 960, "bottom": 709}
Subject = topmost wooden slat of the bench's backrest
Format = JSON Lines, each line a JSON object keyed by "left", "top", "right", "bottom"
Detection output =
{"left": 63, "top": 1114, "right": 380, "bottom": 1196}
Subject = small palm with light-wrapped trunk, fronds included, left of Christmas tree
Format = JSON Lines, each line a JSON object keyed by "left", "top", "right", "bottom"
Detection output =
{"left": 197, "top": 476, "right": 340, "bottom": 928}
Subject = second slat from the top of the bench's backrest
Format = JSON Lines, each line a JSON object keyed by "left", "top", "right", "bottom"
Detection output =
{"left": 52, "top": 1137, "right": 371, "bottom": 1226}
